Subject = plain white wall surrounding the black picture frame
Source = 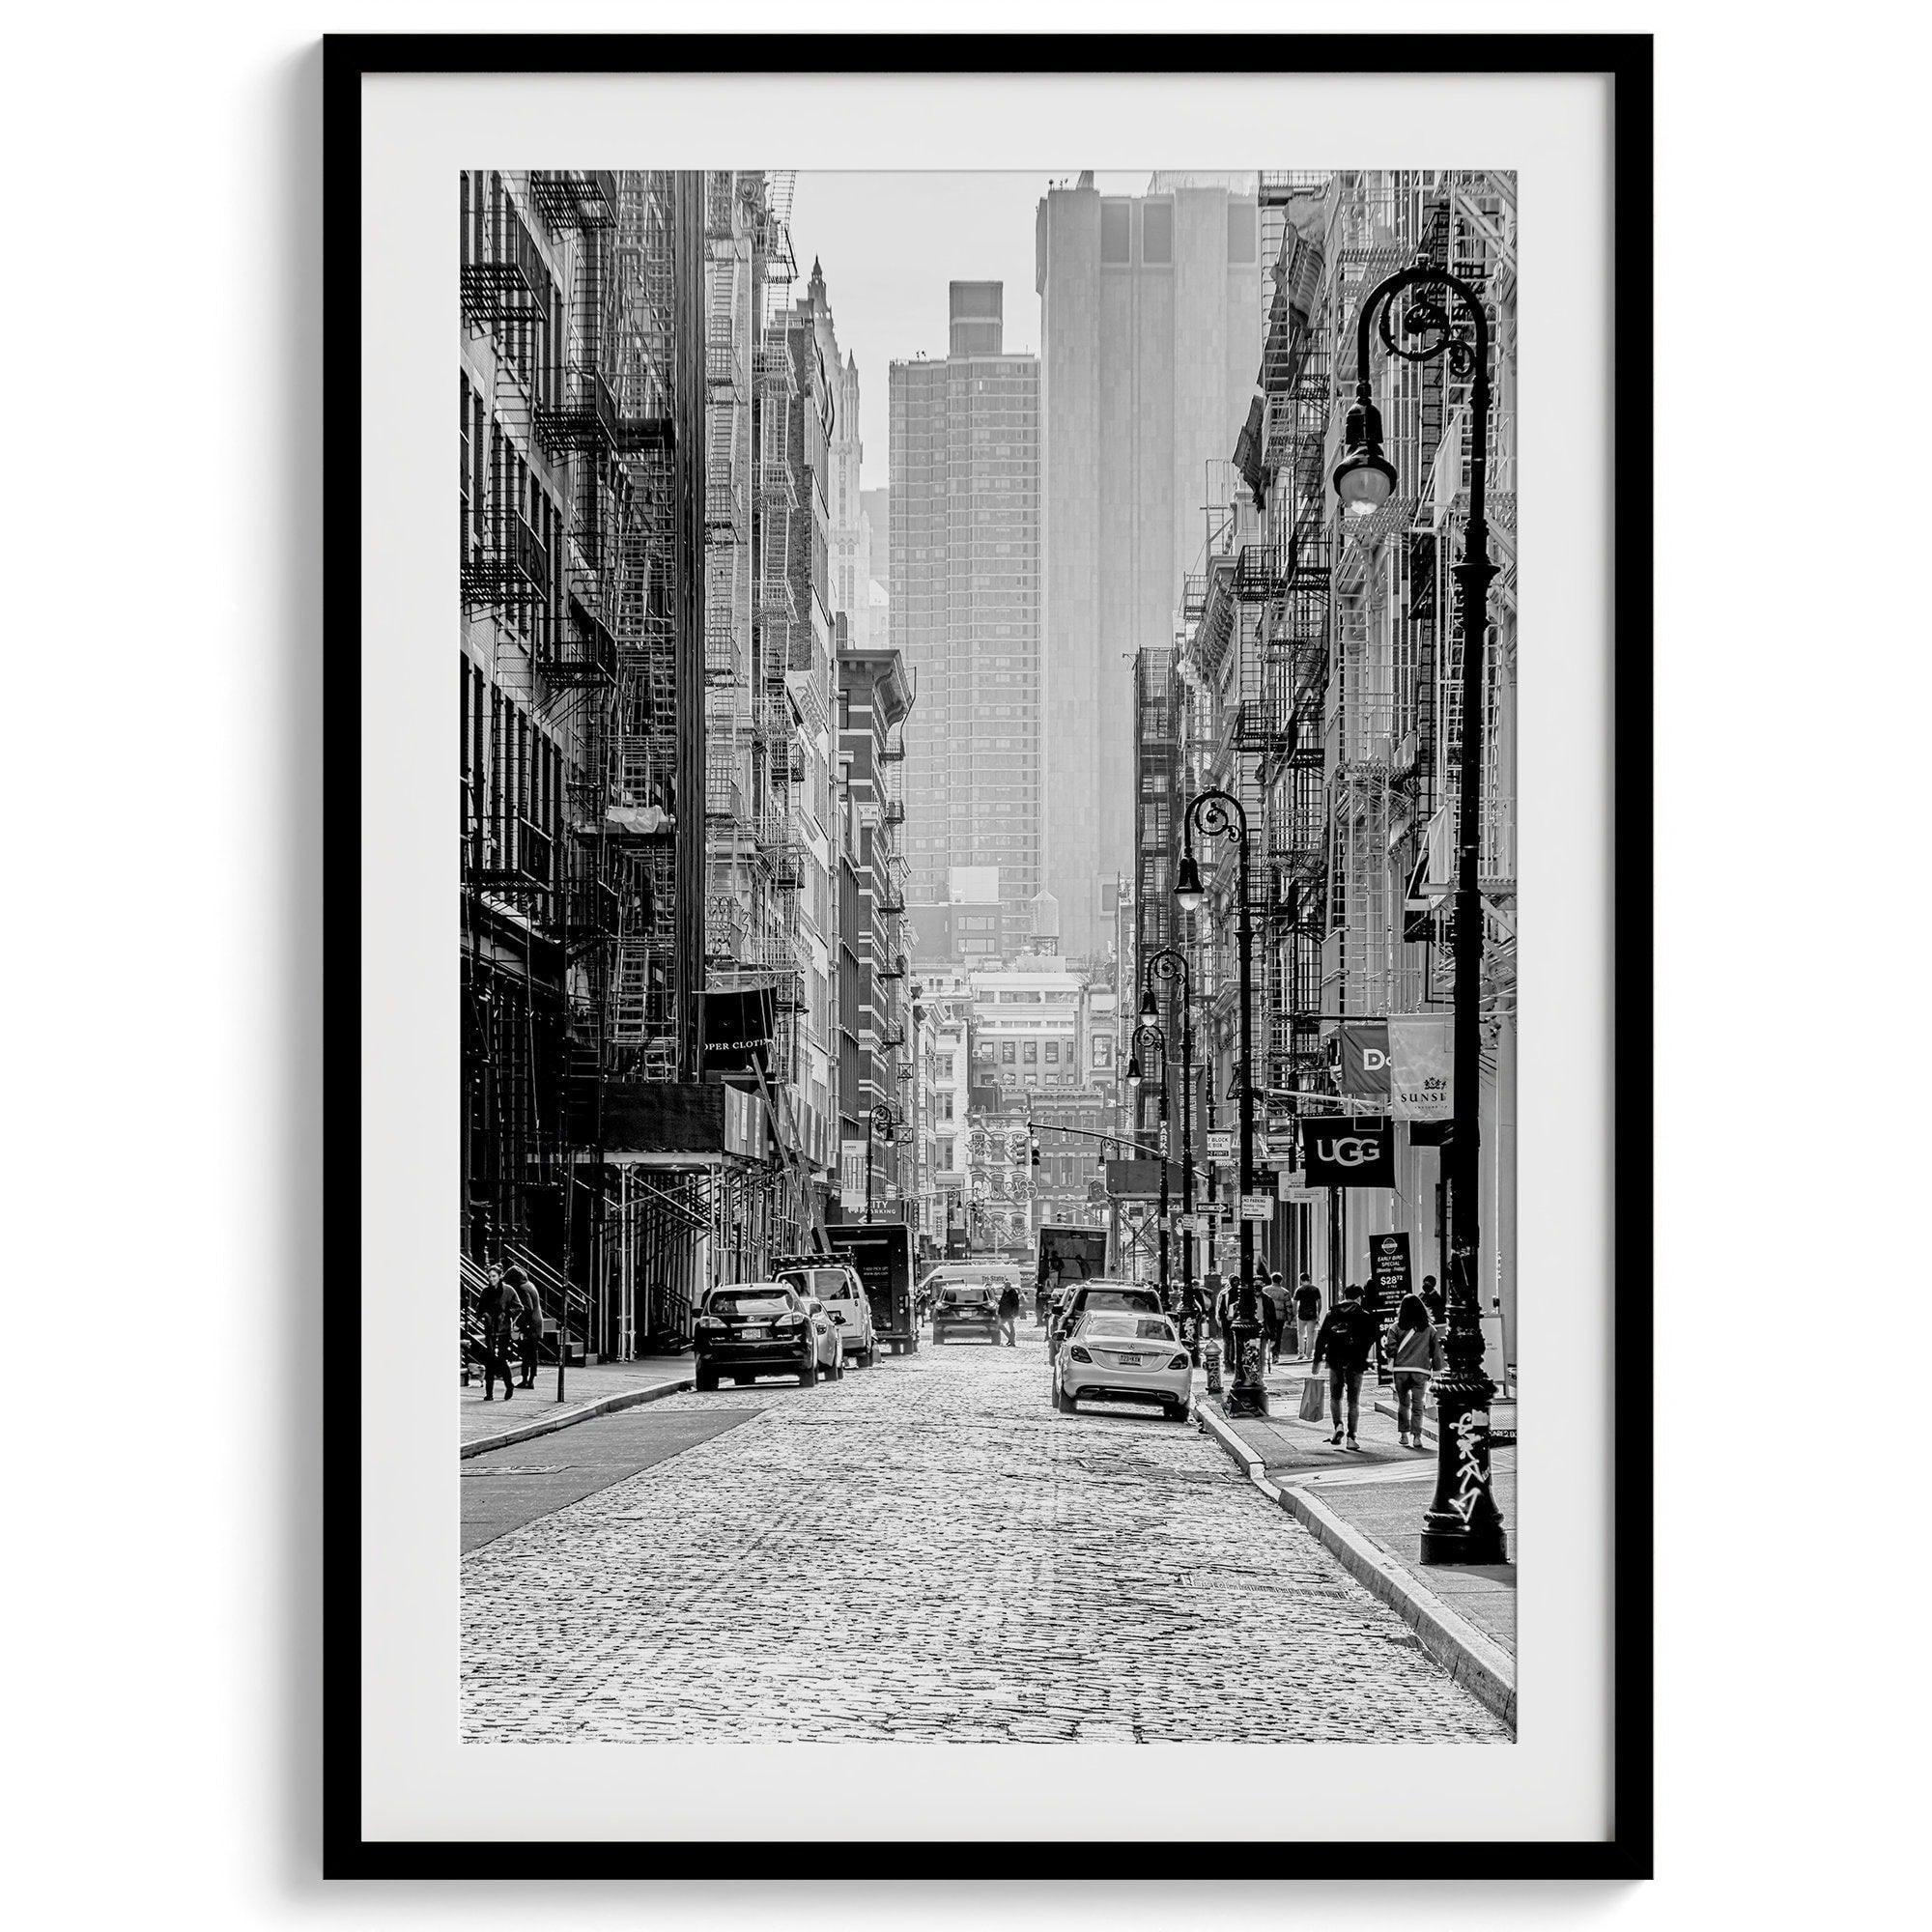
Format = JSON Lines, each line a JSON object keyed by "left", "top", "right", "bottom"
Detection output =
{"left": 0, "top": 0, "right": 1928, "bottom": 1926}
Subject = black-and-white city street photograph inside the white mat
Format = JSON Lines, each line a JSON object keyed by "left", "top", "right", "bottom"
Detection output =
{"left": 450, "top": 168, "right": 1536, "bottom": 1747}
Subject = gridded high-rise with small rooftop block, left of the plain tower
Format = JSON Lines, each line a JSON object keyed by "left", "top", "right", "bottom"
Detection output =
{"left": 889, "top": 282, "right": 1045, "bottom": 949}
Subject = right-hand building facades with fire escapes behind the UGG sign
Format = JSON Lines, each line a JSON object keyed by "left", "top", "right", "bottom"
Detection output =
{"left": 1136, "top": 170, "right": 1517, "bottom": 1376}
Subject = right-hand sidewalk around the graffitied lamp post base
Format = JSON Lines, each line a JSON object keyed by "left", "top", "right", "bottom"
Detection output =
{"left": 1200, "top": 1360, "right": 1519, "bottom": 1723}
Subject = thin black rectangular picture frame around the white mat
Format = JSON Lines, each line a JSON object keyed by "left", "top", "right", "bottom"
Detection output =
{"left": 321, "top": 33, "right": 1654, "bottom": 1882}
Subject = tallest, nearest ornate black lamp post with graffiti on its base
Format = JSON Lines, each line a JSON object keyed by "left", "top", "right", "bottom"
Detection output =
{"left": 1335, "top": 259, "right": 1505, "bottom": 1563}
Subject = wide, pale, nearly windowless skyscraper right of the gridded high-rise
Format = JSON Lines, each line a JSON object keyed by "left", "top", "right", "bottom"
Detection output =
{"left": 1036, "top": 174, "right": 1262, "bottom": 956}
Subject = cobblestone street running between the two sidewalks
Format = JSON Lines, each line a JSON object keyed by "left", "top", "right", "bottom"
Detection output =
{"left": 462, "top": 1325, "right": 1507, "bottom": 1743}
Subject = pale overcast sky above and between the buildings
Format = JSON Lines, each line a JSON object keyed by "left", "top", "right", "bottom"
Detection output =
{"left": 792, "top": 170, "right": 1148, "bottom": 495}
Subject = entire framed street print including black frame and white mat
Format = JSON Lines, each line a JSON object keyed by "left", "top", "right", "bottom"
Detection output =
{"left": 323, "top": 35, "right": 1652, "bottom": 1880}
